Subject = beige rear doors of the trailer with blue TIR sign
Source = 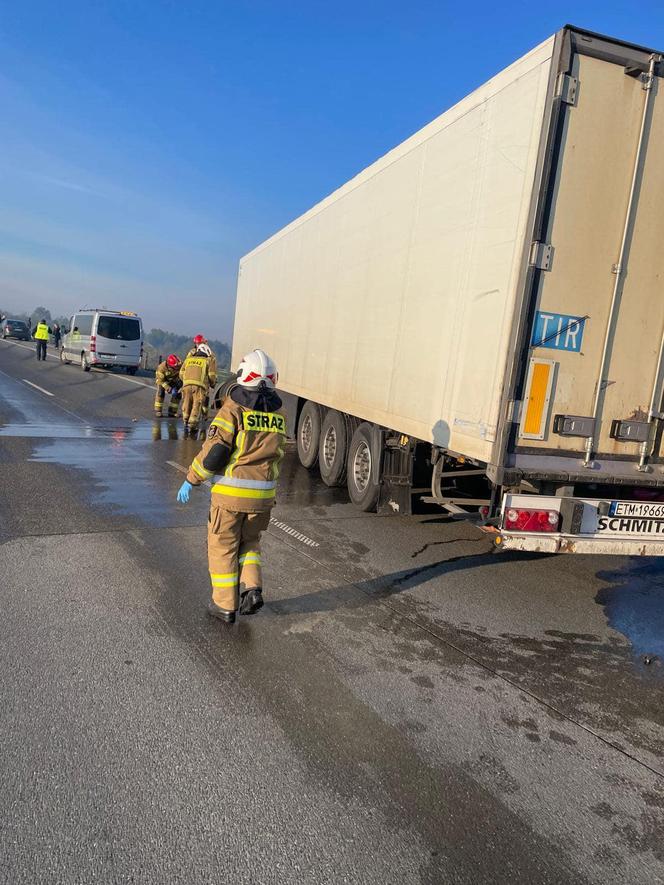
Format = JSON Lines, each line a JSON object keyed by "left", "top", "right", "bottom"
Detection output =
{"left": 517, "top": 45, "right": 664, "bottom": 466}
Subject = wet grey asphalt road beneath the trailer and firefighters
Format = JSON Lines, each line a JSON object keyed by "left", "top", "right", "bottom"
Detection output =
{"left": 0, "top": 334, "right": 664, "bottom": 885}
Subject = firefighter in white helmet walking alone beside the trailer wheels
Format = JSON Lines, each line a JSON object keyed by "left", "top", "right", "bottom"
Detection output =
{"left": 177, "top": 350, "right": 286, "bottom": 623}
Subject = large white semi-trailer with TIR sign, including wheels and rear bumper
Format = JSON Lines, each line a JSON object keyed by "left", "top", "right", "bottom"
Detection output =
{"left": 233, "top": 27, "right": 664, "bottom": 554}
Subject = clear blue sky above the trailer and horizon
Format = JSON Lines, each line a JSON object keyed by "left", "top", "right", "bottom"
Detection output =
{"left": 0, "top": 0, "right": 664, "bottom": 340}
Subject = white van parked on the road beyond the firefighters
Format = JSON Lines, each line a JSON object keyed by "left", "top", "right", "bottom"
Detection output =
{"left": 60, "top": 309, "right": 143, "bottom": 375}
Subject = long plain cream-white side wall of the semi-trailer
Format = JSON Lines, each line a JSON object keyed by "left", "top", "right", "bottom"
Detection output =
{"left": 234, "top": 39, "right": 553, "bottom": 461}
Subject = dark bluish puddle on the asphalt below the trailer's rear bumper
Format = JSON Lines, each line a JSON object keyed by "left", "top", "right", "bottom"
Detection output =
{"left": 595, "top": 559, "right": 664, "bottom": 678}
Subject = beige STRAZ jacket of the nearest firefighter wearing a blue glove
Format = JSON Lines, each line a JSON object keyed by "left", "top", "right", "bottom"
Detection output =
{"left": 187, "top": 396, "right": 286, "bottom": 513}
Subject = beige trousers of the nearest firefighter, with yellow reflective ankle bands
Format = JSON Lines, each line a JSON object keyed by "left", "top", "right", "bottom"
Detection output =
{"left": 208, "top": 504, "right": 270, "bottom": 611}
